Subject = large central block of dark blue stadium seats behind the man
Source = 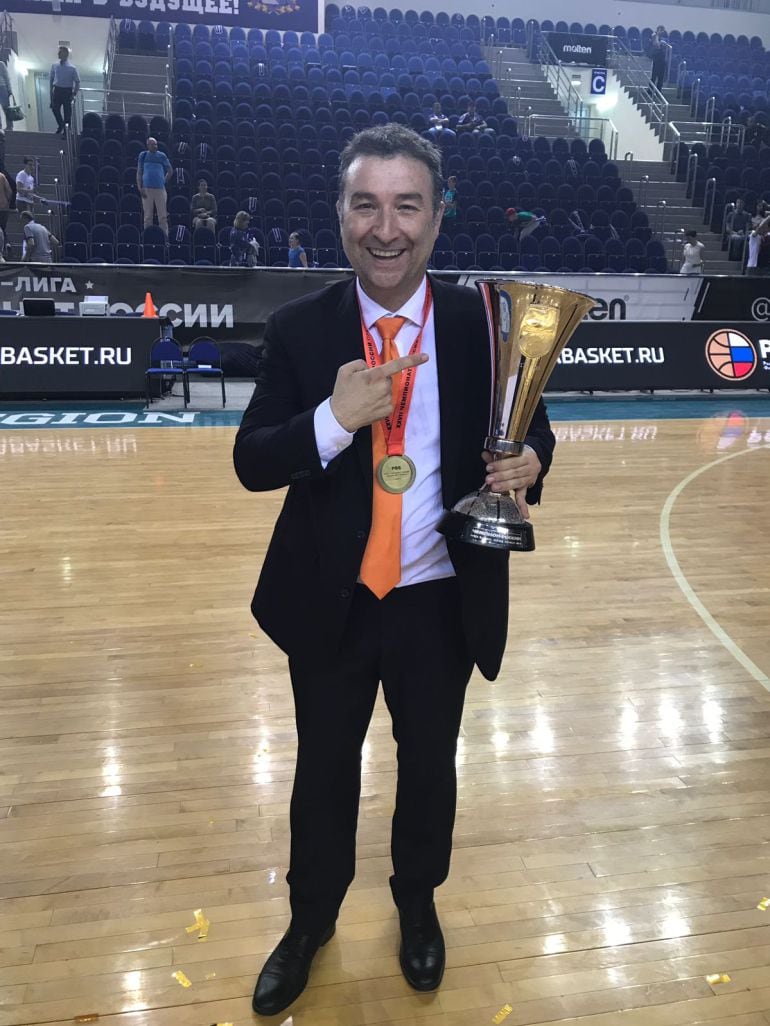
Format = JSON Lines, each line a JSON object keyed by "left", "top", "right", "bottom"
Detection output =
{"left": 65, "top": 5, "right": 666, "bottom": 271}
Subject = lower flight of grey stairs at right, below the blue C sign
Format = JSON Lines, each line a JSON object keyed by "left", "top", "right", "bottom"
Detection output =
{"left": 620, "top": 160, "right": 740, "bottom": 274}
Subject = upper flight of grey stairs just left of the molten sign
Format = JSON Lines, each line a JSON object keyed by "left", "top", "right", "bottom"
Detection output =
{"left": 486, "top": 46, "right": 575, "bottom": 139}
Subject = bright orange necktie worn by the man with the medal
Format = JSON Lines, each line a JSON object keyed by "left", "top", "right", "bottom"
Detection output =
{"left": 360, "top": 317, "right": 407, "bottom": 598}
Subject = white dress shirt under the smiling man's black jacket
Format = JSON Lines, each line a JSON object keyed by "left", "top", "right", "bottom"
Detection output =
{"left": 314, "top": 278, "right": 457, "bottom": 588}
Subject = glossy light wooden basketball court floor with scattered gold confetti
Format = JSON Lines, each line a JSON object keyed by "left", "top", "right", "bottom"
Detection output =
{"left": 0, "top": 404, "right": 770, "bottom": 1026}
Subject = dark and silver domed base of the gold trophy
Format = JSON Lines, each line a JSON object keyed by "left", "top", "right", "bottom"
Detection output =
{"left": 436, "top": 488, "right": 535, "bottom": 552}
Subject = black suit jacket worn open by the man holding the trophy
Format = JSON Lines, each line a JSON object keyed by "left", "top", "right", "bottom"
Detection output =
{"left": 234, "top": 279, "right": 554, "bottom": 680}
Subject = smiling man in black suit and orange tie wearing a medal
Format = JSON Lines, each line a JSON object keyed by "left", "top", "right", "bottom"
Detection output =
{"left": 234, "top": 124, "right": 554, "bottom": 1015}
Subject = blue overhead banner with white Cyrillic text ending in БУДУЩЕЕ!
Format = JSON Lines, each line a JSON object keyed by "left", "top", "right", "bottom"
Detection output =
{"left": 2, "top": 0, "right": 323, "bottom": 32}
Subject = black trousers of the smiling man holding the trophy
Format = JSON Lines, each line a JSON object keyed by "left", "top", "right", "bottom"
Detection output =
{"left": 286, "top": 578, "right": 472, "bottom": 931}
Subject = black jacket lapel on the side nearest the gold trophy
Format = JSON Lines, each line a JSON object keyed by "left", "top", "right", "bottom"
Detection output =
{"left": 430, "top": 278, "right": 468, "bottom": 509}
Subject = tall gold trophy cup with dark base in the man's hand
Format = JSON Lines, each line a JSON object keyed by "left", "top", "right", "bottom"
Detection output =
{"left": 438, "top": 279, "right": 595, "bottom": 552}
